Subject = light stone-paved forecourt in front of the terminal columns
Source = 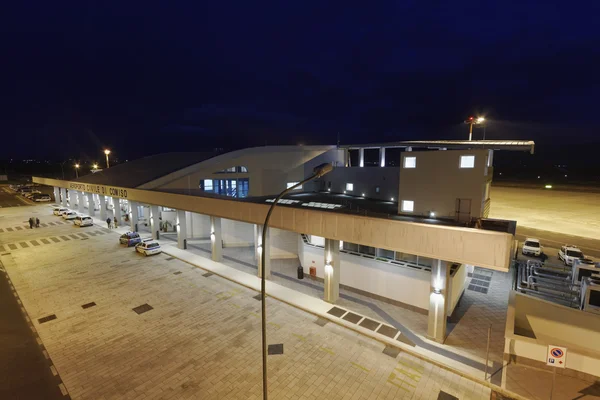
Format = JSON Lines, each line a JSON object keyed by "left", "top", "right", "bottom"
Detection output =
{"left": 0, "top": 207, "right": 490, "bottom": 399}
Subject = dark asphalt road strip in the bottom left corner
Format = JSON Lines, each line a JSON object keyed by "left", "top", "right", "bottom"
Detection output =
{"left": 0, "top": 264, "right": 65, "bottom": 400}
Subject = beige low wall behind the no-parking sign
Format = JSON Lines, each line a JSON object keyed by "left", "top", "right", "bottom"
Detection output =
{"left": 504, "top": 291, "right": 600, "bottom": 379}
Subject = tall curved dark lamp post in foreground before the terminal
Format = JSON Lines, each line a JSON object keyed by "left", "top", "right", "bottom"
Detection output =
{"left": 260, "top": 163, "right": 333, "bottom": 400}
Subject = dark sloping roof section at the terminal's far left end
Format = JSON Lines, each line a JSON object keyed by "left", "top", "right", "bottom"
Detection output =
{"left": 75, "top": 152, "right": 214, "bottom": 188}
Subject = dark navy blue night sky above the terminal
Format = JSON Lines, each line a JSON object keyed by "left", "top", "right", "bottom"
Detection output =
{"left": 0, "top": 0, "right": 600, "bottom": 158}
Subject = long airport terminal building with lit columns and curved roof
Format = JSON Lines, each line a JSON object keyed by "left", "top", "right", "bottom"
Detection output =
{"left": 34, "top": 141, "right": 533, "bottom": 343}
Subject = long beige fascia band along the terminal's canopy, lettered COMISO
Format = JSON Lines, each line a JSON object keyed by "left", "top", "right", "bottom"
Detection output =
{"left": 33, "top": 177, "right": 513, "bottom": 272}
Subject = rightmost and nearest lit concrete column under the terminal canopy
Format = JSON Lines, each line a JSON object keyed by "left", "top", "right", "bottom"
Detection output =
{"left": 427, "top": 260, "right": 450, "bottom": 343}
